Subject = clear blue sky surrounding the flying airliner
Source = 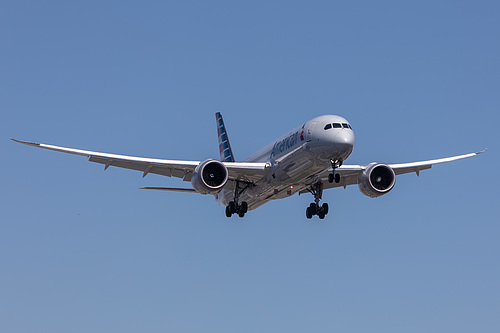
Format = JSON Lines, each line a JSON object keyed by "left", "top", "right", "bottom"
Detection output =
{"left": 0, "top": 1, "right": 500, "bottom": 333}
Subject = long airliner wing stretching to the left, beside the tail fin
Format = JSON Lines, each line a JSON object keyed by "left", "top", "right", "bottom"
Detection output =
{"left": 11, "top": 139, "right": 268, "bottom": 182}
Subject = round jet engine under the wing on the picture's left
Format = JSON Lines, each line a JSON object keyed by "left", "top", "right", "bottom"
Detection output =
{"left": 191, "top": 160, "right": 229, "bottom": 194}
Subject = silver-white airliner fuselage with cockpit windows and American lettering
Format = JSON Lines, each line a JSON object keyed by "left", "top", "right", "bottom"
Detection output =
{"left": 216, "top": 115, "right": 354, "bottom": 210}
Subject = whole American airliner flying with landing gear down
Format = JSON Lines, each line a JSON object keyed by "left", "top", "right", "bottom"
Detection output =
{"left": 11, "top": 112, "right": 486, "bottom": 219}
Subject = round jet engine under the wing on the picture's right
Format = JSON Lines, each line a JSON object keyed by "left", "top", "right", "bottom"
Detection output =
{"left": 358, "top": 163, "right": 396, "bottom": 198}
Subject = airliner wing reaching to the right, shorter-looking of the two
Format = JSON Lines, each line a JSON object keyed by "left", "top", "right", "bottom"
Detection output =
{"left": 320, "top": 149, "right": 486, "bottom": 189}
